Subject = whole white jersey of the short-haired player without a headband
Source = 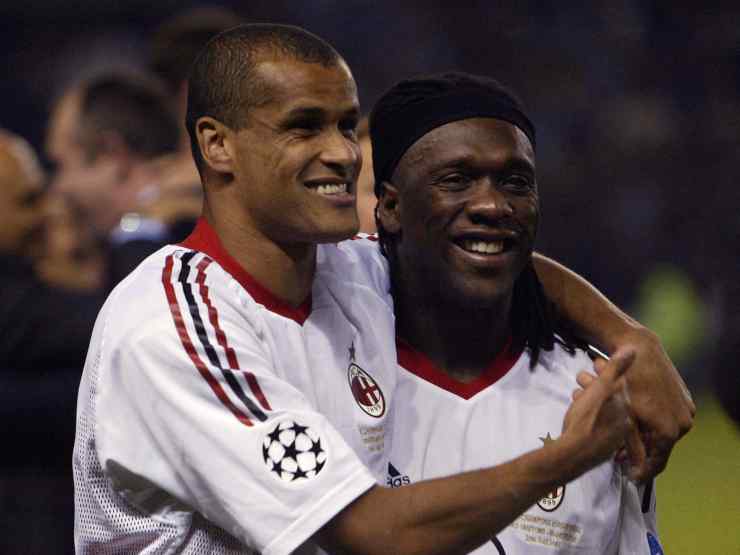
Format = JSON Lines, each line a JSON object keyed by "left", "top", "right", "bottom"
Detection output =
{"left": 73, "top": 220, "right": 396, "bottom": 555}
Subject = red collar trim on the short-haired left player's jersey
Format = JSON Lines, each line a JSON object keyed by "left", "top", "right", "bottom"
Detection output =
{"left": 180, "top": 217, "right": 311, "bottom": 325}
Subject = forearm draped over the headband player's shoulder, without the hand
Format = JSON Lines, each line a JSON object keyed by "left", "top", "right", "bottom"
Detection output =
{"left": 532, "top": 253, "right": 651, "bottom": 351}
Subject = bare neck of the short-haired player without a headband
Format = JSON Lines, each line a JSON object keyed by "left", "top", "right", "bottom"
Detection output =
{"left": 203, "top": 201, "right": 316, "bottom": 308}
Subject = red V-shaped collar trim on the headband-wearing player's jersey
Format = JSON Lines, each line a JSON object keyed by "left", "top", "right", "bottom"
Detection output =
{"left": 396, "top": 337, "right": 522, "bottom": 400}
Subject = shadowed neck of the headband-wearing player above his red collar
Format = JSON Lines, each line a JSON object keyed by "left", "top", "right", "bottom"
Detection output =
{"left": 394, "top": 278, "right": 511, "bottom": 382}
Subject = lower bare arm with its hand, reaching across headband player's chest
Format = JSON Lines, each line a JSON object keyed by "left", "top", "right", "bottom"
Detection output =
{"left": 317, "top": 350, "right": 634, "bottom": 555}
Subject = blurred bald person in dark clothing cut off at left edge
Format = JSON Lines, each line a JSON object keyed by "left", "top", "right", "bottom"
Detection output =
{"left": 0, "top": 131, "right": 102, "bottom": 553}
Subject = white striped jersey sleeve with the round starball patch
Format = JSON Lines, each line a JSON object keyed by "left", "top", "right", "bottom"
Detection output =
{"left": 95, "top": 256, "right": 375, "bottom": 554}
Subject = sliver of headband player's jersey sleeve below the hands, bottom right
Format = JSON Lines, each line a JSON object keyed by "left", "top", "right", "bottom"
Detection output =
{"left": 619, "top": 476, "right": 663, "bottom": 555}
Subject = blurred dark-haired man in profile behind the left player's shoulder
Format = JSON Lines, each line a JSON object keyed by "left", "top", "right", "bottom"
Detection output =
{"left": 46, "top": 72, "right": 184, "bottom": 289}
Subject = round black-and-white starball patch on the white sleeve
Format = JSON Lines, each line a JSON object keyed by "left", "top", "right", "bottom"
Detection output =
{"left": 262, "top": 420, "right": 327, "bottom": 482}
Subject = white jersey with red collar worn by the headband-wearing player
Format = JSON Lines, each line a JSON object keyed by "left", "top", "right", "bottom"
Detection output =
{"left": 387, "top": 340, "right": 662, "bottom": 555}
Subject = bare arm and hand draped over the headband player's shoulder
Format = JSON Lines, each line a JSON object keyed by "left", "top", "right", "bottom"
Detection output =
{"left": 533, "top": 253, "right": 696, "bottom": 480}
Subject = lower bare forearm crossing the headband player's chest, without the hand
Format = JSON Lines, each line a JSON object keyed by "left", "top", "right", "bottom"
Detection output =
{"left": 320, "top": 438, "right": 585, "bottom": 555}
